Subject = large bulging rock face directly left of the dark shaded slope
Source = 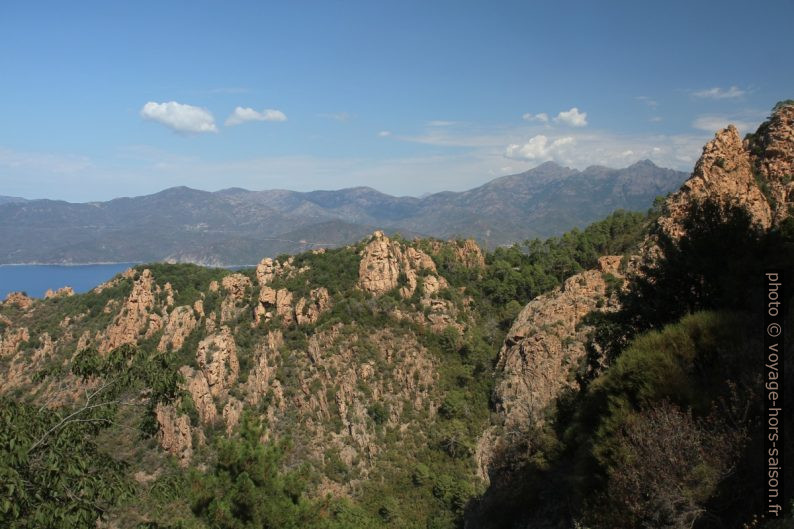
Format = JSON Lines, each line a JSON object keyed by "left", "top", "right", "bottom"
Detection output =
{"left": 494, "top": 256, "right": 621, "bottom": 432}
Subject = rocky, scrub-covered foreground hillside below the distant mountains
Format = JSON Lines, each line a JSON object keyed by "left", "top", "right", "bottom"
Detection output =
{"left": 0, "top": 103, "right": 794, "bottom": 529}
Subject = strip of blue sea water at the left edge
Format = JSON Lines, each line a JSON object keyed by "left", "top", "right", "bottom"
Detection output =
{"left": 0, "top": 263, "right": 135, "bottom": 301}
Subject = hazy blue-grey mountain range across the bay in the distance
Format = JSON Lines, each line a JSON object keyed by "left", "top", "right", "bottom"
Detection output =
{"left": 0, "top": 160, "right": 688, "bottom": 265}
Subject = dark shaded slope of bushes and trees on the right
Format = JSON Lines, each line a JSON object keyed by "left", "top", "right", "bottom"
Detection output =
{"left": 470, "top": 202, "right": 794, "bottom": 529}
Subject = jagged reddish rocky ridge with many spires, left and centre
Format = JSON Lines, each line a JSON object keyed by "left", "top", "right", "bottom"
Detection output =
{"left": 0, "top": 232, "right": 476, "bottom": 482}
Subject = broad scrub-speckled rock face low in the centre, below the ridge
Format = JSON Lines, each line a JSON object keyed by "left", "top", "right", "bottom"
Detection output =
{"left": 270, "top": 324, "right": 438, "bottom": 478}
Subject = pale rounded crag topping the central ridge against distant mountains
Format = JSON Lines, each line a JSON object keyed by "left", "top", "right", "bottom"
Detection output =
{"left": 358, "top": 231, "right": 447, "bottom": 298}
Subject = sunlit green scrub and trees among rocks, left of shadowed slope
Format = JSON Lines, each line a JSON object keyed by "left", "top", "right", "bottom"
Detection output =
{"left": 2, "top": 207, "right": 647, "bottom": 529}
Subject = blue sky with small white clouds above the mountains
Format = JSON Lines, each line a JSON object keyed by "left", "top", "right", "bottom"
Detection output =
{"left": 0, "top": 0, "right": 794, "bottom": 202}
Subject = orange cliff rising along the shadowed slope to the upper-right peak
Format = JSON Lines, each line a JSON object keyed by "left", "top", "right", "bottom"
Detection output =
{"left": 477, "top": 105, "right": 794, "bottom": 477}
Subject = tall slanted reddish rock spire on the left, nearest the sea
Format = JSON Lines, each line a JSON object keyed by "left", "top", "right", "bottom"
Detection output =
{"left": 98, "top": 268, "right": 155, "bottom": 354}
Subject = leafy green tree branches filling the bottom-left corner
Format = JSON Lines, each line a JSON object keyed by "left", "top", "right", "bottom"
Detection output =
{"left": 0, "top": 398, "right": 130, "bottom": 528}
